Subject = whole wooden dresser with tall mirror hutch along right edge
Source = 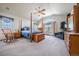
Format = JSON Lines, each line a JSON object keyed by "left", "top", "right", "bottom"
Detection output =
{"left": 64, "top": 4, "right": 79, "bottom": 56}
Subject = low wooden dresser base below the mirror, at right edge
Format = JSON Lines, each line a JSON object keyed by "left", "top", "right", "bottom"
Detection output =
{"left": 64, "top": 32, "right": 79, "bottom": 56}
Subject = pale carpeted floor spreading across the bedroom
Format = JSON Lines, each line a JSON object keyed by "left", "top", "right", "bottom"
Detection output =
{"left": 0, "top": 36, "right": 69, "bottom": 56}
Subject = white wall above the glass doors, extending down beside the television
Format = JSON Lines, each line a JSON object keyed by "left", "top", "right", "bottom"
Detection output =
{"left": 43, "top": 15, "right": 66, "bottom": 32}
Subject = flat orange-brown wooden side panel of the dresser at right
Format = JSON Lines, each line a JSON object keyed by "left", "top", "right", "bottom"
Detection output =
{"left": 69, "top": 35, "right": 79, "bottom": 56}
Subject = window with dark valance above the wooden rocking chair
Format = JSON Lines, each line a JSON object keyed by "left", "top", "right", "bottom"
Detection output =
{"left": 0, "top": 16, "right": 13, "bottom": 29}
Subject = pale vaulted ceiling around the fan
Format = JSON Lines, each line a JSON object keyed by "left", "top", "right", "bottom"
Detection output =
{"left": 0, "top": 3, "right": 74, "bottom": 18}
